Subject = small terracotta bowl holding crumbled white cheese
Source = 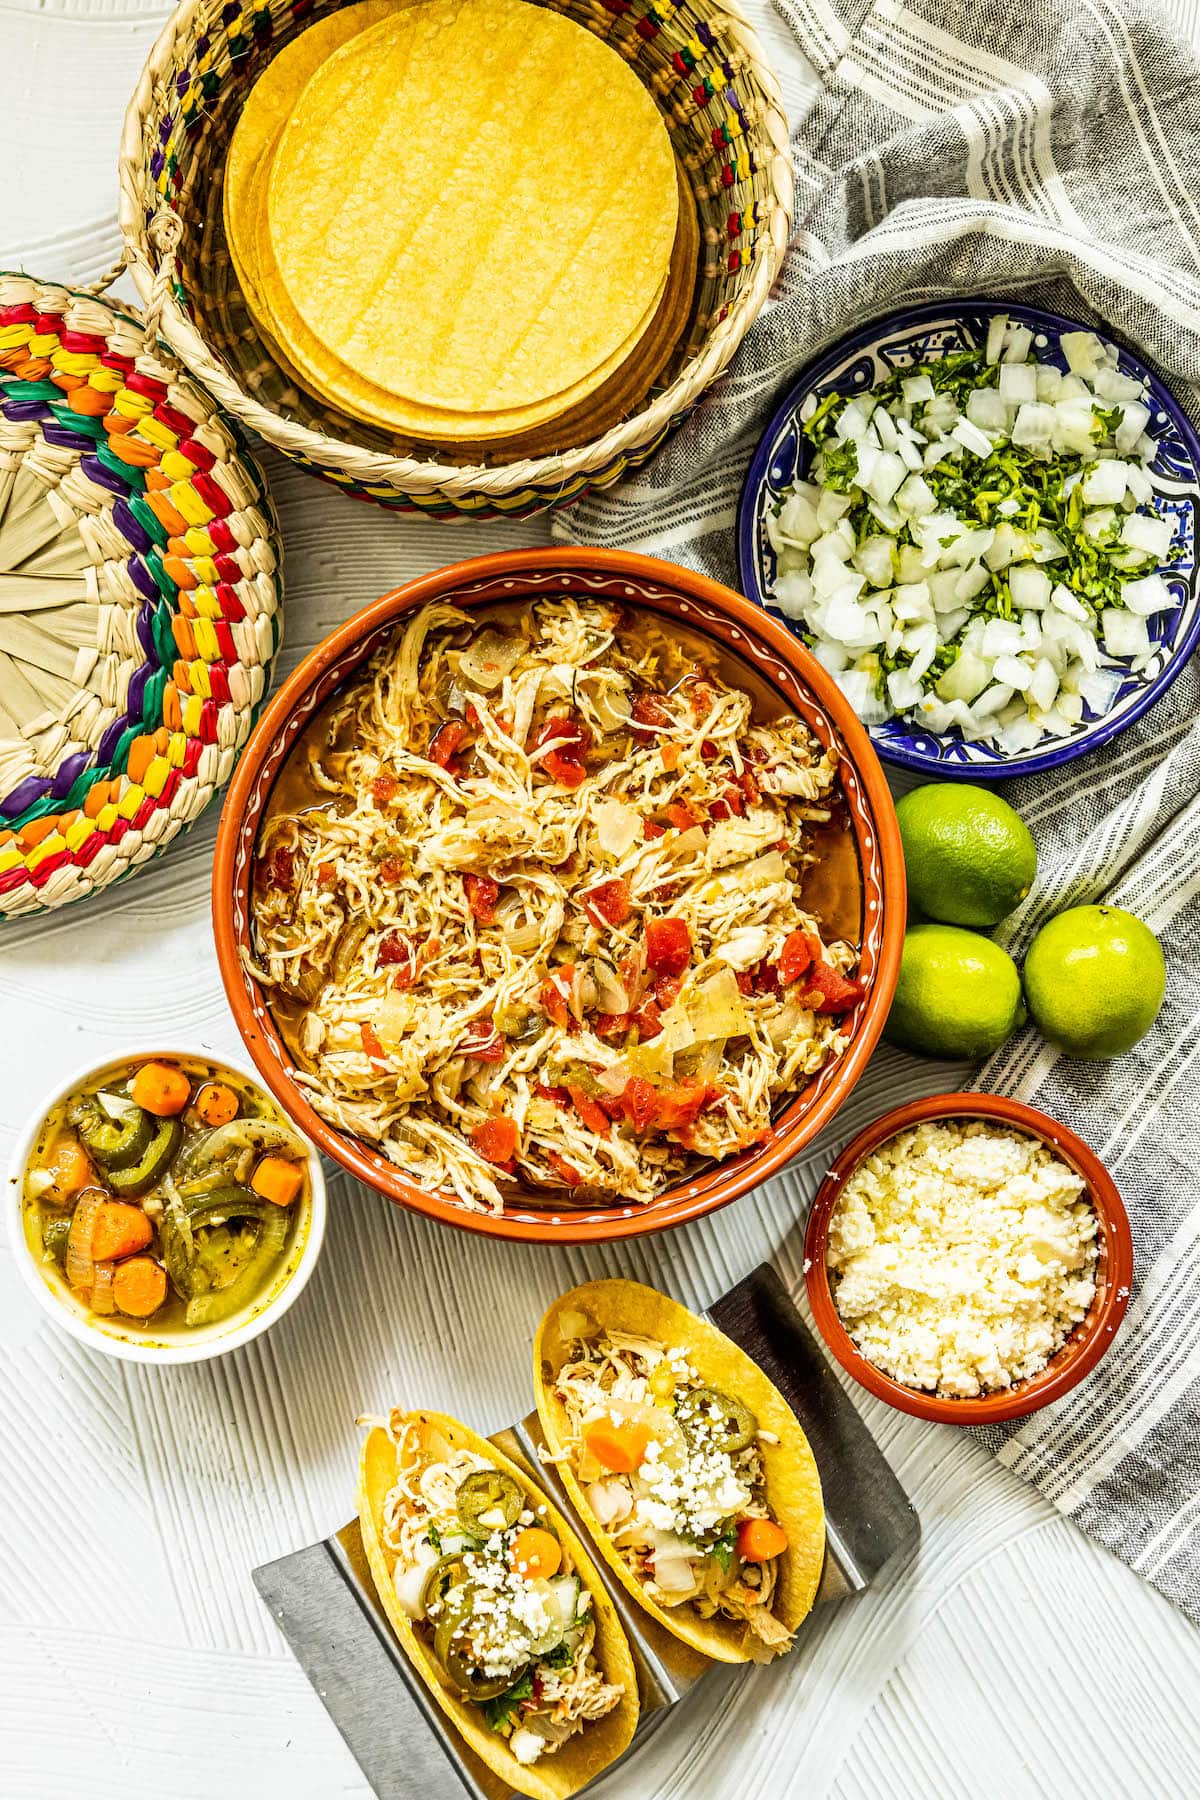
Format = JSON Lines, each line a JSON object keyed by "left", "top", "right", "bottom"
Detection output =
{"left": 804, "top": 1094, "right": 1133, "bottom": 1426}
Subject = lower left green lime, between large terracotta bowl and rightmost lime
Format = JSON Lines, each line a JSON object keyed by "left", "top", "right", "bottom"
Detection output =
{"left": 883, "top": 925, "right": 1025, "bottom": 1058}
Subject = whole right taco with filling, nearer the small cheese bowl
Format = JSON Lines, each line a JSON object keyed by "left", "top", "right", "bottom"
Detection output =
{"left": 534, "top": 1282, "right": 826, "bottom": 1663}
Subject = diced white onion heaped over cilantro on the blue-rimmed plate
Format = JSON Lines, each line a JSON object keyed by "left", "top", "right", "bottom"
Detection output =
{"left": 766, "top": 315, "right": 1177, "bottom": 756}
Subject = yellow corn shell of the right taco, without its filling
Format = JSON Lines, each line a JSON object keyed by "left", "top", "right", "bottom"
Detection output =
{"left": 533, "top": 1282, "right": 826, "bottom": 1663}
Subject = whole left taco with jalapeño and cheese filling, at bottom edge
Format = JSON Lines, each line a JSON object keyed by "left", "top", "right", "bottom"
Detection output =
{"left": 358, "top": 1411, "right": 639, "bottom": 1800}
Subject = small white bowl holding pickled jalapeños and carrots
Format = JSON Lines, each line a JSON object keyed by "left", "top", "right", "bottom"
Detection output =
{"left": 4, "top": 1044, "right": 326, "bottom": 1363}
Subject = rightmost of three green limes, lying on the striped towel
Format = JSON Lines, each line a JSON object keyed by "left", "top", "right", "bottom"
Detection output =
{"left": 1024, "top": 905, "right": 1166, "bottom": 1058}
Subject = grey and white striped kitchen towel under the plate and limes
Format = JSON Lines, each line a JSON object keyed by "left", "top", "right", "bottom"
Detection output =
{"left": 554, "top": 0, "right": 1200, "bottom": 1624}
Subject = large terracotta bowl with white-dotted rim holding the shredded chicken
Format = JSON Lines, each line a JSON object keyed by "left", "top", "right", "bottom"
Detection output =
{"left": 212, "top": 547, "right": 905, "bottom": 1244}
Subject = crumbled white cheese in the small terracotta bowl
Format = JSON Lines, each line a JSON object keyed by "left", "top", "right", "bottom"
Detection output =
{"left": 828, "top": 1120, "right": 1097, "bottom": 1397}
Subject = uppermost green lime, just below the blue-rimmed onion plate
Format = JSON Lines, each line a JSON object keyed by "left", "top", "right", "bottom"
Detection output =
{"left": 896, "top": 781, "right": 1038, "bottom": 925}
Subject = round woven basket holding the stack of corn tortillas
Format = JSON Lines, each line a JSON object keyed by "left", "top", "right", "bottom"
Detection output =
{"left": 121, "top": 0, "right": 792, "bottom": 517}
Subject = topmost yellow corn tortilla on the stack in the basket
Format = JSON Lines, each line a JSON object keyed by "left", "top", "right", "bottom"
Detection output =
{"left": 268, "top": 0, "right": 678, "bottom": 414}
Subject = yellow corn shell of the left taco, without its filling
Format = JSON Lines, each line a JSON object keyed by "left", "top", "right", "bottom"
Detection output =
{"left": 358, "top": 1411, "right": 639, "bottom": 1800}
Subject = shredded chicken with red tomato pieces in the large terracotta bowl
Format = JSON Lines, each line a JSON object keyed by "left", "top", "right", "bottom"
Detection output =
{"left": 252, "top": 596, "right": 862, "bottom": 1211}
